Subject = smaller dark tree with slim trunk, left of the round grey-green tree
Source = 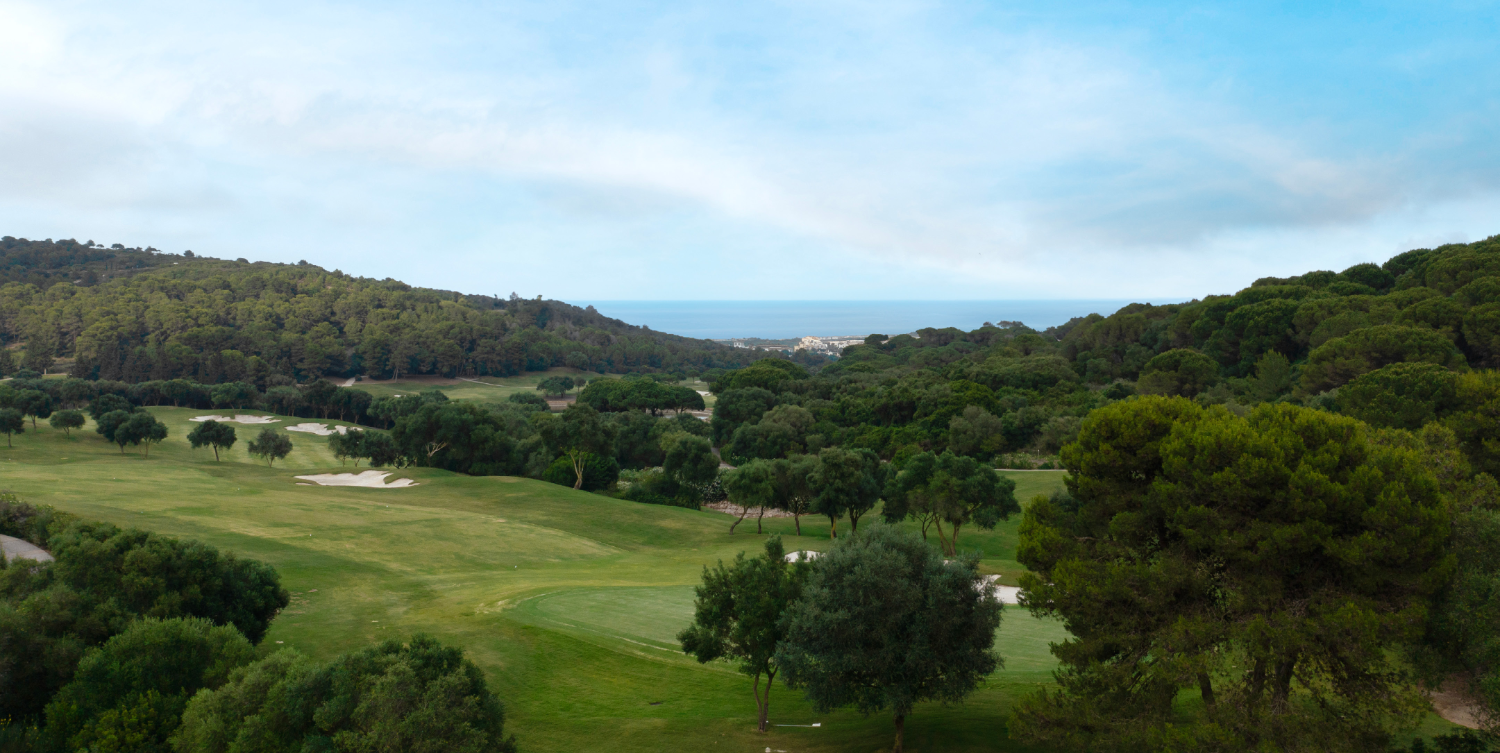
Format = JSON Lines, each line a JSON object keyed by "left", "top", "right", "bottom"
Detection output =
{"left": 677, "top": 536, "right": 807, "bottom": 732}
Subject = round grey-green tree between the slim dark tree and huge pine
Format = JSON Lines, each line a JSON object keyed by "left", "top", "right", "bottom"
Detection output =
{"left": 774, "top": 525, "right": 1001, "bottom": 753}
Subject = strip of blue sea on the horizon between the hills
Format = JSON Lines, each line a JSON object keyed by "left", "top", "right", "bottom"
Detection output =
{"left": 570, "top": 300, "right": 1130, "bottom": 341}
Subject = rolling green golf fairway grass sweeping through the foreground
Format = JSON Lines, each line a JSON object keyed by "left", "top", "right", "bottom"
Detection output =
{"left": 11, "top": 408, "right": 1452, "bottom": 753}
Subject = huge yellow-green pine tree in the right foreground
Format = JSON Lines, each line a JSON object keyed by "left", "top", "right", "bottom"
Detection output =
{"left": 1011, "top": 398, "right": 1451, "bottom": 752}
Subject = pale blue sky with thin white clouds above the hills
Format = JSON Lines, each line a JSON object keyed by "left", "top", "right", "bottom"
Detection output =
{"left": 0, "top": 0, "right": 1500, "bottom": 303}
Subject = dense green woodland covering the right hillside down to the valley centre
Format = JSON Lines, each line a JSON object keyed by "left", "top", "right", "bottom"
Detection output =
{"left": 687, "top": 239, "right": 1500, "bottom": 473}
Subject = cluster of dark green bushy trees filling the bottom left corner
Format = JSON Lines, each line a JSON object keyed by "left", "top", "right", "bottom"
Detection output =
{"left": 0, "top": 495, "right": 515, "bottom": 753}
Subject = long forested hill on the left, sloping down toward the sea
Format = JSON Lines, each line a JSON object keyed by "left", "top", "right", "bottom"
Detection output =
{"left": 0, "top": 236, "right": 765, "bottom": 384}
